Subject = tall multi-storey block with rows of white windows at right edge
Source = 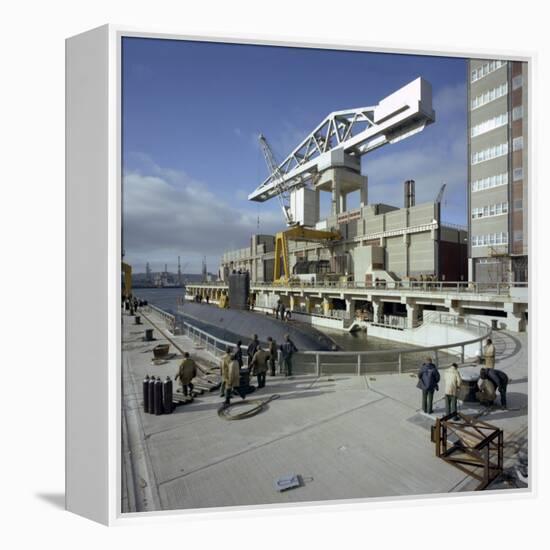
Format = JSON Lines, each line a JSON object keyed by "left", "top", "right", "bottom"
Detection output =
{"left": 468, "top": 59, "right": 528, "bottom": 282}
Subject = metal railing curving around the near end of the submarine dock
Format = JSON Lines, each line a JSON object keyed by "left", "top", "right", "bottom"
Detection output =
{"left": 144, "top": 306, "right": 491, "bottom": 376}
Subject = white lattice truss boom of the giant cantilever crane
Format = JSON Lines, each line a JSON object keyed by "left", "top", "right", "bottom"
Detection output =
{"left": 248, "top": 77, "right": 435, "bottom": 202}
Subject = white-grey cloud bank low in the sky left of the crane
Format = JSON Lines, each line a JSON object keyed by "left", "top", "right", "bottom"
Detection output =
{"left": 123, "top": 156, "right": 282, "bottom": 272}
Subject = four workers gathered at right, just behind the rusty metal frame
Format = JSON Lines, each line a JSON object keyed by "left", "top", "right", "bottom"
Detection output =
{"left": 417, "top": 338, "right": 508, "bottom": 418}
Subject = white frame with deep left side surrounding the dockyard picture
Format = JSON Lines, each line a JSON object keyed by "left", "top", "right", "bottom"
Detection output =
{"left": 66, "top": 25, "right": 536, "bottom": 525}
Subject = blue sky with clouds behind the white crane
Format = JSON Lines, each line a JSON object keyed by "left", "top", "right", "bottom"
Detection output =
{"left": 122, "top": 38, "right": 467, "bottom": 272}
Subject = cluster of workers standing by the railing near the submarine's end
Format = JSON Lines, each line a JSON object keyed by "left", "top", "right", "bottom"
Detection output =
{"left": 220, "top": 334, "right": 298, "bottom": 405}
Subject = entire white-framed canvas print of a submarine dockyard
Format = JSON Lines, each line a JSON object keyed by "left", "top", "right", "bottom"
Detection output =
{"left": 66, "top": 25, "right": 533, "bottom": 524}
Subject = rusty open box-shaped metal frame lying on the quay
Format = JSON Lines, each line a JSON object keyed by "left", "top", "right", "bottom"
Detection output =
{"left": 432, "top": 413, "right": 504, "bottom": 491}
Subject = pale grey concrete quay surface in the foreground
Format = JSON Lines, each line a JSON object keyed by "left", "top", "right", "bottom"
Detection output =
{"left": 122, "top": 312, "right": 528, "bottom": 512}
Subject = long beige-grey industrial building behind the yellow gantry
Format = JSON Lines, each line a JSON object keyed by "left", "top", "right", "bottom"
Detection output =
{"left": 220, "top": 197, "right": 467, "bottom": 286}
